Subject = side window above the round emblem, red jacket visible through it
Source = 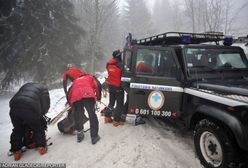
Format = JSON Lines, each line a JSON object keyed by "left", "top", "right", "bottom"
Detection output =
{"left": 136, "top": 49, "right": 176, "bottom": 77}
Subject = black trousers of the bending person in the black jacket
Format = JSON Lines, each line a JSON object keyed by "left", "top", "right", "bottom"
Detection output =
{"left": 10, "top": 109, "right": 47, "bottom": 151}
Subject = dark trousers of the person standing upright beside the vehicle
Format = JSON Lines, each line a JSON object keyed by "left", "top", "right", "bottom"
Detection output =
{"left": 108, "top": 85, "right": 124, "bottom": 122}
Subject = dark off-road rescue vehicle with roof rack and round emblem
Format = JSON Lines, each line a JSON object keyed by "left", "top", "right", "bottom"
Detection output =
{"left": 122, "top": 32, "right": 248, "bottom": 168}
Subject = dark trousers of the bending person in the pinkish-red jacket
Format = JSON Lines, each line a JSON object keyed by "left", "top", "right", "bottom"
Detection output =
{"left": 72, "top": 98, "right": 99, "bottom": 138}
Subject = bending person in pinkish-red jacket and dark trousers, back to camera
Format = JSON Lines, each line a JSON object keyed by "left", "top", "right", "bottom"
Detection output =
{"left": 68, "top": 74, "right": 101, "bottom": 144}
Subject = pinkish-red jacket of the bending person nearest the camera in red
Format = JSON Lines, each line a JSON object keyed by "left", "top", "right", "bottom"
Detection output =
{"left": 68, "top": 74, "right": 99, "bottom": 105}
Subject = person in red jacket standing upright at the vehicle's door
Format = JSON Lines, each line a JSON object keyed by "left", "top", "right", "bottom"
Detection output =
{"left": 105, "top": 50, "right": 124, "bottom": 127}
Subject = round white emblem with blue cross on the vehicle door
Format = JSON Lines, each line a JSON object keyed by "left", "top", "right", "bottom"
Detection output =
{"left": 147, "top": 91, "right": 164, "bottom": 110}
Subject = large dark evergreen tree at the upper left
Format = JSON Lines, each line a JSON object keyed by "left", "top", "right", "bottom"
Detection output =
{"left": 0, "top": 0, "right": 84, "bottom": 88}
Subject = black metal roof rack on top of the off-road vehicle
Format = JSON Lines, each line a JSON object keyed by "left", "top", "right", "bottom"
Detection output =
{"left": 137, "top": 32, "right": 224, "bottom": 45}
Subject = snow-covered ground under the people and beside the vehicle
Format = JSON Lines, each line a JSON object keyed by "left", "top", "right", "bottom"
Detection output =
{"left": 0, "top": 89, "right": 201, "bottom": 168}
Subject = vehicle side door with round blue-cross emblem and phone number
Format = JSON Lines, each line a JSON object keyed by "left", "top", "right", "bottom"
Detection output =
{"left": 128, "top": 46, "right": 183, "bottom": 118}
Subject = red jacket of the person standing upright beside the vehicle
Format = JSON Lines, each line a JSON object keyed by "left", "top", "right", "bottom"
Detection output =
{"left": 107, "top": 58, "right": 122, "bottom": 87}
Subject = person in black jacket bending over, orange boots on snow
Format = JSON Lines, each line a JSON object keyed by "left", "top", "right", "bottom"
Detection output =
{"left": 9, "top": 83, "right": 50, "bottom": 160}
